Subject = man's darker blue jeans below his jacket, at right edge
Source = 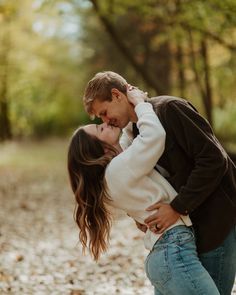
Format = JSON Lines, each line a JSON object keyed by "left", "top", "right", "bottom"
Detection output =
{"left": 199, "top": 226, "right": 236, "bottom": 295}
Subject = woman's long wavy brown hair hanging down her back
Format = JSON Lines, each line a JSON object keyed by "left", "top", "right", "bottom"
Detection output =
{"left": 68, "top": 128, "right": 117, "bottom": 261}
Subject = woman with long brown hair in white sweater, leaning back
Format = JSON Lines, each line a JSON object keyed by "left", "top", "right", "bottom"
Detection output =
{"left": 68, "top": 89, "right": 219, "bottom": 295}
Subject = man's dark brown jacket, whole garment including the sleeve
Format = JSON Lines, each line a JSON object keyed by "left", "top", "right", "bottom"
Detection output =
{"left": 134, "top": 96, "right": 236, "bottom": 253}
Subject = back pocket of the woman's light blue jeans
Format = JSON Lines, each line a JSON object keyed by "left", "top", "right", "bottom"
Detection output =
{"left": 145, "top": 247, "right": 171, "bottom": 286}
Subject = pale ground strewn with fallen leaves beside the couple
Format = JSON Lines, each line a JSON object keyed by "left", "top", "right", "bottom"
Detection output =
{"left": 0, "top": 140, "right": 235, "bottom": 295}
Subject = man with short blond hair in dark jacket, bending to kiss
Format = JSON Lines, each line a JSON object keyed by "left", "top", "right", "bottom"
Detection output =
{"left": 84, "top": 72, "right": 236, "bottom": 295}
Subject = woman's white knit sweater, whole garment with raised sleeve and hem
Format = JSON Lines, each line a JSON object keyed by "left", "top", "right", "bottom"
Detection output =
{"left": 105, "top": 102, "right": 191, "bottom": 250}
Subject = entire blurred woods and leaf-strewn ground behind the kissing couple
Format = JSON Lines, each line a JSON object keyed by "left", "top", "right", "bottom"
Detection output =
{"left": 0, "top": 0, "right": 236, "bottom": 295}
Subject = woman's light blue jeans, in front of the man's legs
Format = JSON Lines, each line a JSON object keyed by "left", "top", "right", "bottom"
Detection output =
{"left": 145, "top": 225, "right": 220, "bottom": 295}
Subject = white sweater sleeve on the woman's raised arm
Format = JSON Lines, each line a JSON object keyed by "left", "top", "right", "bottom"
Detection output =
{"left": 109, "top": 102, "right": 166, "bottom": 180}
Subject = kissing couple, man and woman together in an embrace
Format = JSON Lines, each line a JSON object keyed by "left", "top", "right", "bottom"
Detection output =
{"left": 68, "top": 71, "right": 236, "bottom": 295}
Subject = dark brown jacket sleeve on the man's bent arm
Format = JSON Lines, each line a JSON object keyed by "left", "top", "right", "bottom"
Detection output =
{"left": 164, "top": 101, "right": 227, "bottom": 214}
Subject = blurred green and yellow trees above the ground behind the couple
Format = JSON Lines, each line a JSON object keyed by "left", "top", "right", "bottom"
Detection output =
{"left": 0, "top": 0, "right": 236, "bottom": 144}
